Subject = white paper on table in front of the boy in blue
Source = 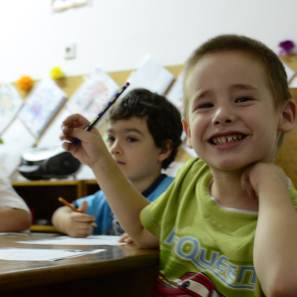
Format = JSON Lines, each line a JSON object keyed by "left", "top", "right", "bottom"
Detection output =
{"left": 17, "top": 235, "right": 126, "bottom": 245}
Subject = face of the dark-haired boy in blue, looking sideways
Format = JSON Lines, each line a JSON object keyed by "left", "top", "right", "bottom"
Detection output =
{"left": 107, "top": 116, "right": 161, "bottom": 192}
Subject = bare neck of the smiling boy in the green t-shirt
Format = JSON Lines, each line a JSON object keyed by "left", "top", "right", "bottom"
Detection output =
{"left": 210, "top": 170, "right": 258, "bottom": 211}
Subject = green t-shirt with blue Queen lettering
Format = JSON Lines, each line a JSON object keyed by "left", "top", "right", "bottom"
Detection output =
{"left": 141, "top": 158, "right": 297, "bottom": 297}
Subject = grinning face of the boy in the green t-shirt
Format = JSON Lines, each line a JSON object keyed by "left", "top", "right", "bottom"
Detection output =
{"left": 184, "top": 51, "right": 281, "bottom": 170}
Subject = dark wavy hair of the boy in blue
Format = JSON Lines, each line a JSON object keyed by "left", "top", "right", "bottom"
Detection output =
{"left": 108, "top": 89, "right": 183, "bottom": 169}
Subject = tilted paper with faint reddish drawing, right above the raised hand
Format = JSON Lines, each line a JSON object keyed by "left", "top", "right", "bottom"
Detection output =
{"left": 66, "top": 69, "right": 119, "bottom": 122}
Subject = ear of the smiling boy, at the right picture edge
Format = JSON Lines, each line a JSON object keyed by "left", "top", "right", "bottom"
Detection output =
{"left": 278, "top": 99, "right": 297, "bottom": 132}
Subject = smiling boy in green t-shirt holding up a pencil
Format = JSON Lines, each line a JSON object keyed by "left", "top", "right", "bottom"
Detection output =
{"left": 61, "top": 35, "right": 297, "bottom": 297}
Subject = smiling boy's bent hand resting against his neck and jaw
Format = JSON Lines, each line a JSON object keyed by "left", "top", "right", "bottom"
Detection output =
{"left": 241, "top": 162, "right": 288, "bottom": 199}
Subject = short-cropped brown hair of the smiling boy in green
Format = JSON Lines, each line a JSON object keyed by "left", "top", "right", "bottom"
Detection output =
{"left": 183, "top": 35, "right": 292, "bottom": 119}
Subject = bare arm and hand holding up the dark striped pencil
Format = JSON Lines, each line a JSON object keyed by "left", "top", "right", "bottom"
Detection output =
{"left": 60, "top": 114, "right": 159, "bottom": 248}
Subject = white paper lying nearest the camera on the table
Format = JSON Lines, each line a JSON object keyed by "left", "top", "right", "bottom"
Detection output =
{"left": 0, "top": 248, "right": 106, "bottom": 261}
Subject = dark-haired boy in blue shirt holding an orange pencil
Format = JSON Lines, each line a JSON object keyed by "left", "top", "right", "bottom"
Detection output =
{"left": 52, "top": 89, "right": 182, "bottom": 238}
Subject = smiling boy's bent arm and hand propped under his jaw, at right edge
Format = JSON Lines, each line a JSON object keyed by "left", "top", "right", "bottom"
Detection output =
{"left": 242, "top": 163, "right": 297, "bottom": 296}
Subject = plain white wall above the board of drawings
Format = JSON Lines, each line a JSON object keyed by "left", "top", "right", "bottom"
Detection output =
{"left": 0, "top": 0, "right": 297, "bottom": 81}
